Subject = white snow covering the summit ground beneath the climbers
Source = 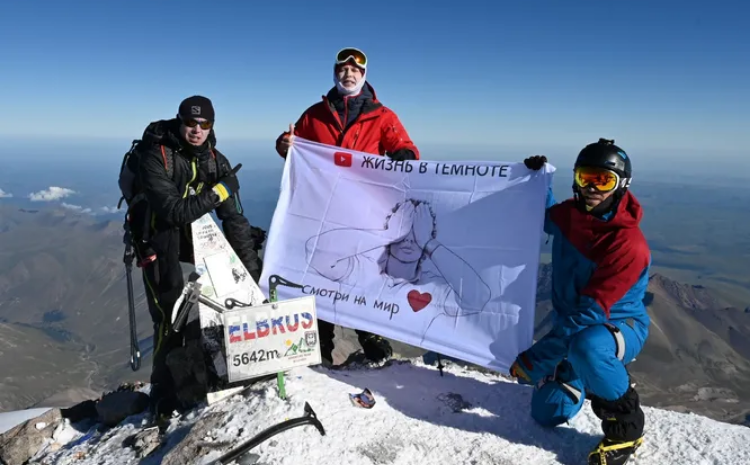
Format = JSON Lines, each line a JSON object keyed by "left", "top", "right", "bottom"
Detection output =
{"left": 10, "top": 360, "right": 750, "bottom": 465}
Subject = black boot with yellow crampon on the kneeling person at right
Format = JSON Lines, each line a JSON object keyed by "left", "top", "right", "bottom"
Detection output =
{"left": 588, "top": 387, "right": 645, "bottom": 465}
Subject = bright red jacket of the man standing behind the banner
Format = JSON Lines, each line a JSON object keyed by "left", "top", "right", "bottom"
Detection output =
{"left": 276, "top": 83, "right": 419, "bottom": 160}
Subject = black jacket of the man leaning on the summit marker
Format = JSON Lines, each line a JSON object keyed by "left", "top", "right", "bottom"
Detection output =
{"left": 138, "top": 118, "right": 265, "bottom": 282}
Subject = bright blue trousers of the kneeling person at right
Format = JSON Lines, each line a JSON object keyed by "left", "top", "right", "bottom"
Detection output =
{"left": 531, "top": 321, "right": 648, "bottom": 426}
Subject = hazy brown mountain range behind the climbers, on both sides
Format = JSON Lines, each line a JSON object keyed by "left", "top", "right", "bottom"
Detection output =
{"left": 0, "top": 205, "right": 750, "bottom": 423}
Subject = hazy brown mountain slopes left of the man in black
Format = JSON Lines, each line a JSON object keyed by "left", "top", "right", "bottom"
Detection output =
{"left": 0, "top": 206, "right": 152, "bottom": 410}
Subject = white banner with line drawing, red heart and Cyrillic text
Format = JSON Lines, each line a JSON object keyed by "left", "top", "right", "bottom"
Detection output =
{"left": 260, "top": 137, "right": 554, "bottom": 372}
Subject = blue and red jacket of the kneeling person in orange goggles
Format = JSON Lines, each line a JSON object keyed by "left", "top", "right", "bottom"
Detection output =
{"left": 519, "top": 189, "right": 651, "bottom": 383}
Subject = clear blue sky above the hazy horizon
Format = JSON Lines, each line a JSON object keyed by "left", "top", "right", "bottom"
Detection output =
{"left": 0, "top": 0, "right": 750, "bottom": 161}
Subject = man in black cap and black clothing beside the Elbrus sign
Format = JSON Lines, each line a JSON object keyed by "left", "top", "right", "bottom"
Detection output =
{"left": 131, "top": 96, "right": 265, "bottom": 414}
